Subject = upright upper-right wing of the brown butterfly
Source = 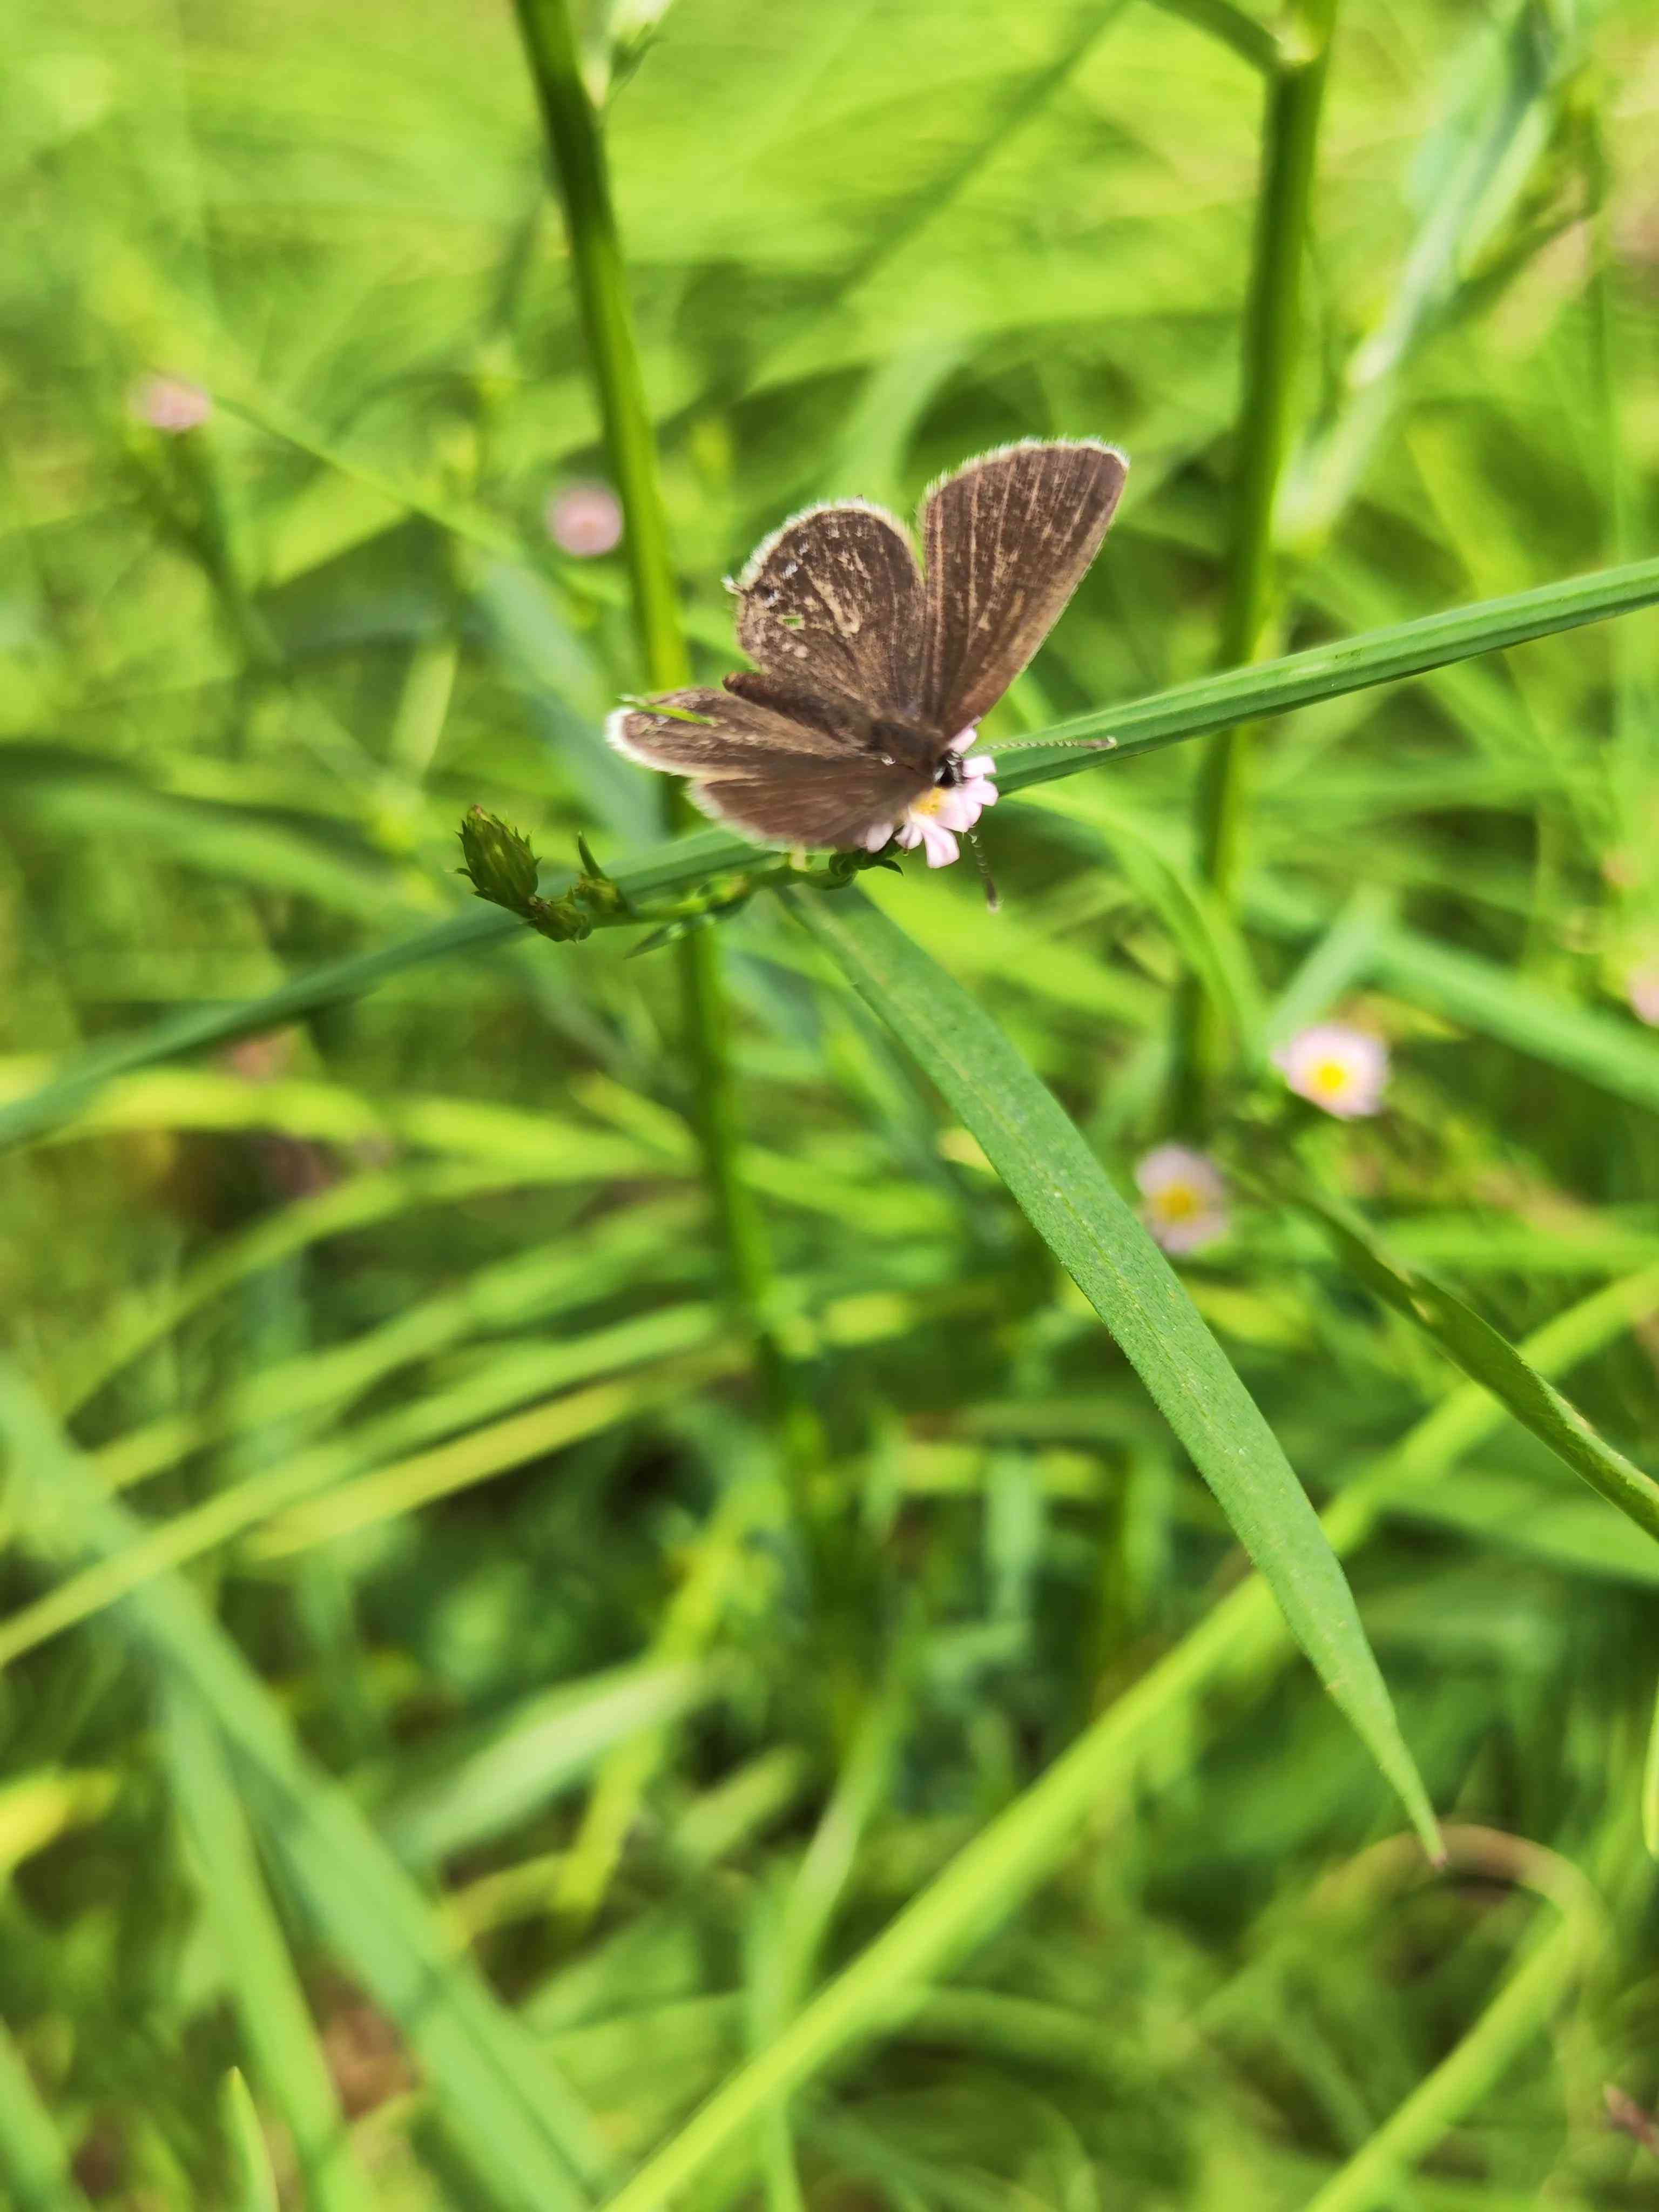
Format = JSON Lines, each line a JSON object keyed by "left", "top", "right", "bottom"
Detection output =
{"left": 922, "top": 440, "right": 1128, "bottom": 734}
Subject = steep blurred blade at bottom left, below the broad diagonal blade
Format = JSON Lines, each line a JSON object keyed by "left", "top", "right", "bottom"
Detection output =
{"left": 164, "top": 1690, "right": 374, "bottom": 2212}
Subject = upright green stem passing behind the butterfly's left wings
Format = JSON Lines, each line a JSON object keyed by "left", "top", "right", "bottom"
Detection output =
{"left": 515, "top": 0, "right": 803, "bottom": 1435}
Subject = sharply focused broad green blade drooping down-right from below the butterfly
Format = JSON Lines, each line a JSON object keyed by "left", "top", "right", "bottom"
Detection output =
{"left": 794, "top": 894, "right": 1435, "bottom": 1849}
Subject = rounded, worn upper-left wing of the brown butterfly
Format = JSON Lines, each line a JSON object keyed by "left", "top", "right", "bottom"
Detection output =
{"left": 737, "top": 500, "right": 925, "bottom": 719}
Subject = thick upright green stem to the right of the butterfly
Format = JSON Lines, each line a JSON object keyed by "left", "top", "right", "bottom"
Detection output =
{"left": 1172, "top": 0, "right": 1336, "bottom": 1132}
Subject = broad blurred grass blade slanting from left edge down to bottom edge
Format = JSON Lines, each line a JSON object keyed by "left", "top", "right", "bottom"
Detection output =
{"left": 0, "top": 1372, "right": 604, "bottom": 2212}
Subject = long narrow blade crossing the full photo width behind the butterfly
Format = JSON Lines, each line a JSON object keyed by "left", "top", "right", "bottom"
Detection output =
{"left": 0, "top": 559, "right": 1659, "bottom": 1146}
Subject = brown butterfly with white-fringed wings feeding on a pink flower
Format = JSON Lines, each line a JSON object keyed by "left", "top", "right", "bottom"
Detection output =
{"left": 606, "top": 438, "right": 1128, "bottom": 867}
